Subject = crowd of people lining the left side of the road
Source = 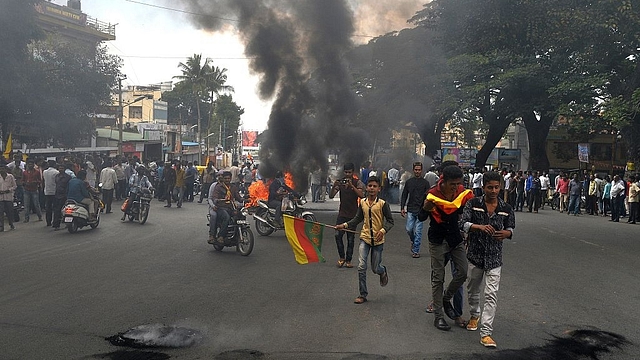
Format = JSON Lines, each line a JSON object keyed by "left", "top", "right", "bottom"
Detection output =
{"left": 0, "top": 152, "right": 259, "bottom": 231}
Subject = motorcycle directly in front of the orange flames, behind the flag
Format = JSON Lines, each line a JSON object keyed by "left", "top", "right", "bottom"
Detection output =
{"left": 253, "top": 192, "right": 317, "bottom": 236}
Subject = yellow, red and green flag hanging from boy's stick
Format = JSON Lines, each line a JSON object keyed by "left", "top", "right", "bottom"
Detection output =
{"left": 282, "top": 214, "right": 325, "bottom": 264}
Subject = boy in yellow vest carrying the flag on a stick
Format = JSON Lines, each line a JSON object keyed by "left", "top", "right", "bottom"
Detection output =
{"left": 336, "top": 176, "right": 393, "bottom": 304}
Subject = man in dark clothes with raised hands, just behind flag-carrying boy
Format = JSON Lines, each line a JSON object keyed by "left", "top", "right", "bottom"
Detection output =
{"left": 329, "top": 163, "right": 365, "bottom": 268}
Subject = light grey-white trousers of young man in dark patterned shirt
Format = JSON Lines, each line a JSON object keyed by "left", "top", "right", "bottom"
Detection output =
{"left": 467, "top": 264, "right": 502, "bottom": 337}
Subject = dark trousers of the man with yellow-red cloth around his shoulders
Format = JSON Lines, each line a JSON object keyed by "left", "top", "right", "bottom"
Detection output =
{"left": 429, "top": 241, "right": 468, "bottom": 319}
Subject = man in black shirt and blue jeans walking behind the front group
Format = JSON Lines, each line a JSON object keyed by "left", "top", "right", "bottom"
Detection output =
{"left": 400, "top": 162, "right": 431, "bottom": 259}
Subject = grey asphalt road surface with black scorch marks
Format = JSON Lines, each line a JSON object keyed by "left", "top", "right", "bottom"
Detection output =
{"left": 0, "top": 201, "right": 640, "bottom": 359}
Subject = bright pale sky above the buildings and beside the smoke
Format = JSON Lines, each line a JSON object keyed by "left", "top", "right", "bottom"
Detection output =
{"left": 70, "top": 0, "right": 425, "bottom": 131}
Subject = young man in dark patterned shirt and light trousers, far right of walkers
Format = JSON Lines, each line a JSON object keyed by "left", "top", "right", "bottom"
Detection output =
{"left": 459, "top": 172, "right": 516, "bottom": 347}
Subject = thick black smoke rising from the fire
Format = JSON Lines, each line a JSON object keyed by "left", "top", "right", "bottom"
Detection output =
{"left": 178, "top": 0, "right": 419, "bottom": 190}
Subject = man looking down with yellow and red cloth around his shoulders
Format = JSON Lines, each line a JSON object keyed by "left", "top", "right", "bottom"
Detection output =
{"left": 418, "top": 162, "right": 473, "bottom": 331}
